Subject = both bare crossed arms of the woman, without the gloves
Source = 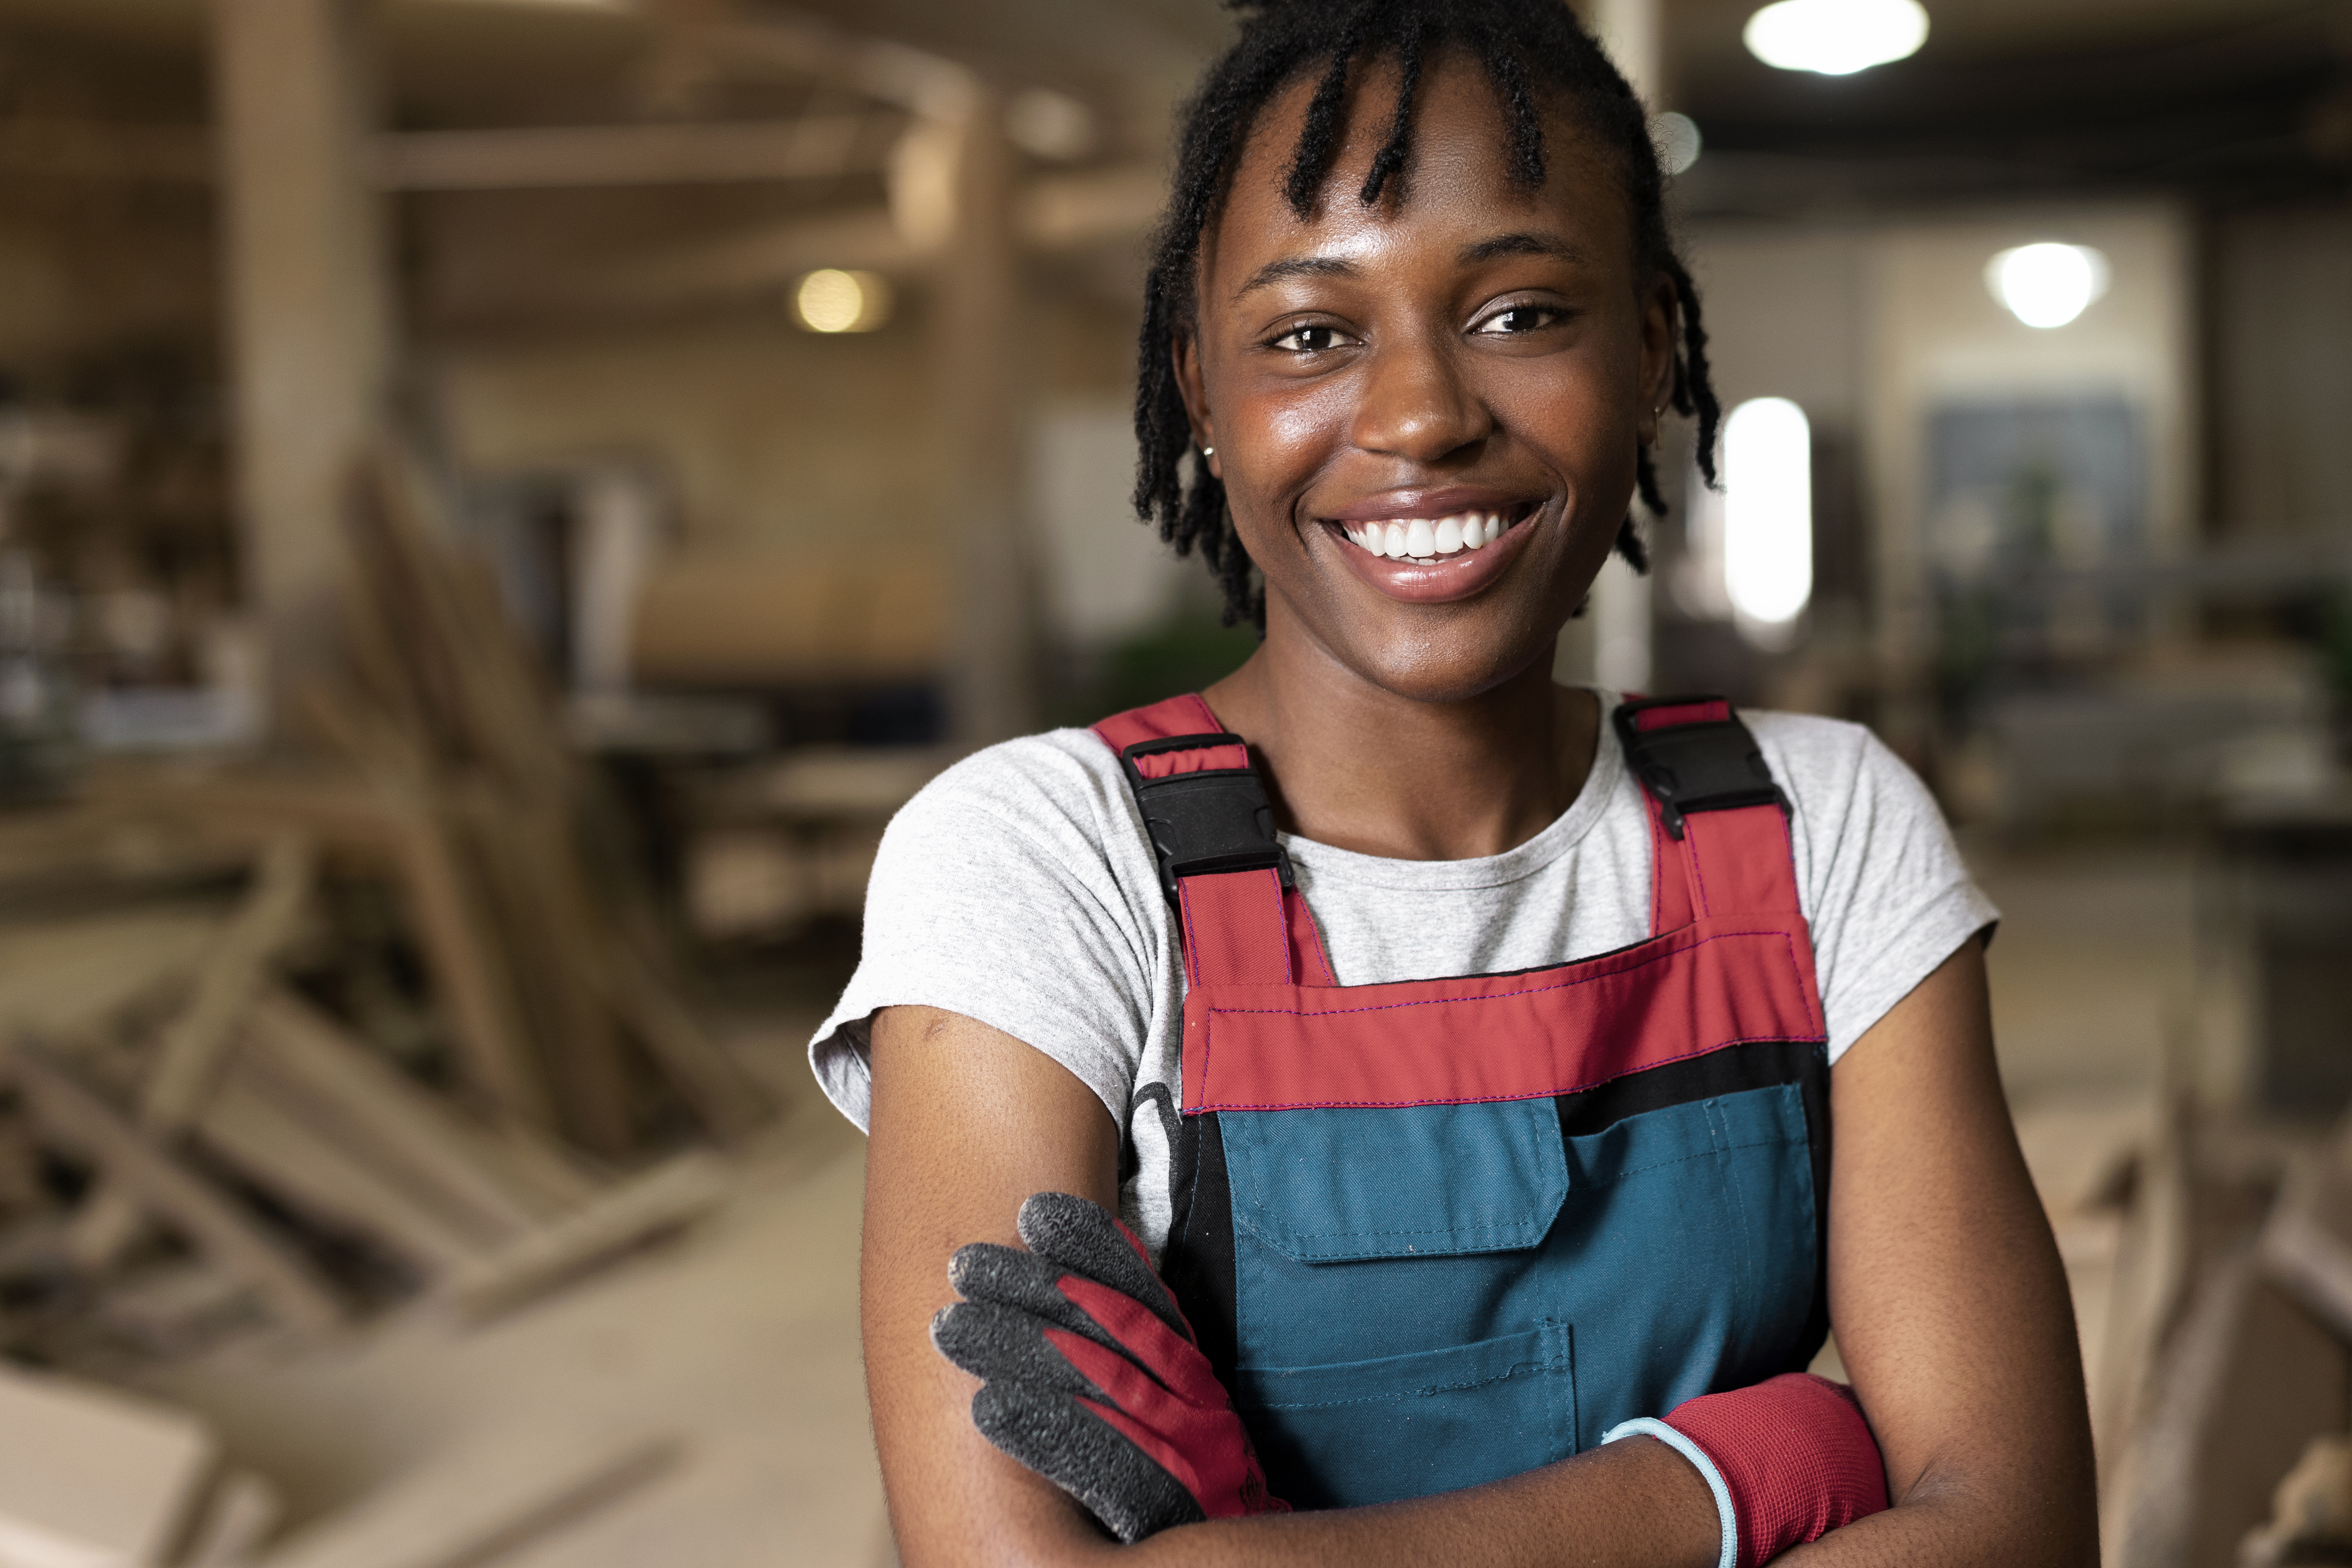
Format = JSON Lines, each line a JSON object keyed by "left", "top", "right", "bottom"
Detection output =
{"left": 861, "top": 943, "right": 2096, "bottom": 1568}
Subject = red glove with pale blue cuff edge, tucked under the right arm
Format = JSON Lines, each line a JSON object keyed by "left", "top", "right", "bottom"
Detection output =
{"left": 1602, "top": 1373, "right": 1886, "bottom": 1568}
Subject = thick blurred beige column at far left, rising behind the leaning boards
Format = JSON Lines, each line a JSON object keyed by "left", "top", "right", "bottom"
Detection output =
{"left": 212, "top": 0, "right": 393, "bottom": 724}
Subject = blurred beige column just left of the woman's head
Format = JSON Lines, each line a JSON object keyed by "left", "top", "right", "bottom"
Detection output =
{"left": 934, "top": 84, "right": 1037, "bottom": 745}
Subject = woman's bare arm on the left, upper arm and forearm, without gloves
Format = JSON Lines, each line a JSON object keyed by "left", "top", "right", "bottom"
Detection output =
{"left": 861, "top": 1008, "right": 1719, "bottom": 1568}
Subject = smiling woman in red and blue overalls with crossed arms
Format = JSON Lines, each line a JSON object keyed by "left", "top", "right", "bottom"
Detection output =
{"left": 812, "top": 0, "right": 2096, "bottom": 1568}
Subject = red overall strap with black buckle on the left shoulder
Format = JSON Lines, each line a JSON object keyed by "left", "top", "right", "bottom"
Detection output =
{"left": 1094, "top": 694, "right": 1336, "bottom": 985}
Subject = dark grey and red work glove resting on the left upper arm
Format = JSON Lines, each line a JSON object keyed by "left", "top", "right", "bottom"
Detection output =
{"left": 931, "top": 1192, "right": 1289, "bottom": 1542}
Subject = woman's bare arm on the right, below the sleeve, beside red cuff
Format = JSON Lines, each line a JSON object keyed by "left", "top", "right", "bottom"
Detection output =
{"left": 1785, "top": 943, "right": 2098, "bottom": 1568}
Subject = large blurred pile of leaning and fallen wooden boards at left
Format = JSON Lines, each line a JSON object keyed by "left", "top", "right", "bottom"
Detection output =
{"left": 0, "top": 449, "right": 776, "bottom": 1342}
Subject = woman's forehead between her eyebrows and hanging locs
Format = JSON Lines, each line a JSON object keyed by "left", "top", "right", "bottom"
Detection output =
{"left": 1202, "top": 50, "right": 1632, "bottom": 284}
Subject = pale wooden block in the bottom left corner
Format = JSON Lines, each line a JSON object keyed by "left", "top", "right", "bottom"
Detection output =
{"left": 0, "top": 1363, "right": 216, "bottom": 1568}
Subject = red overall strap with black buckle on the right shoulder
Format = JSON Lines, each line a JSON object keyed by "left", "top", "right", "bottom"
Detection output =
{"left": 1614, "top": 696, "right": 1801, "bottom": 936}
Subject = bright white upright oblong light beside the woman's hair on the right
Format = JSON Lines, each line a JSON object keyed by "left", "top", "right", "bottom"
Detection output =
{"left": 1724, "top": 397, "right": 1814, "bottom": 625}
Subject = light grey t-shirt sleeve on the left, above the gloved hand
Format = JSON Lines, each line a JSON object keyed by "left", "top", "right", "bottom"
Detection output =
{"left": 809, "top": 738, "right": 1167, "bottom": 1128}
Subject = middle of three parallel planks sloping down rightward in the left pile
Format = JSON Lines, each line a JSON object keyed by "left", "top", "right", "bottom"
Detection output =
{"left": 195, "top": 1070, "right": 482, "bottom": 1276}
